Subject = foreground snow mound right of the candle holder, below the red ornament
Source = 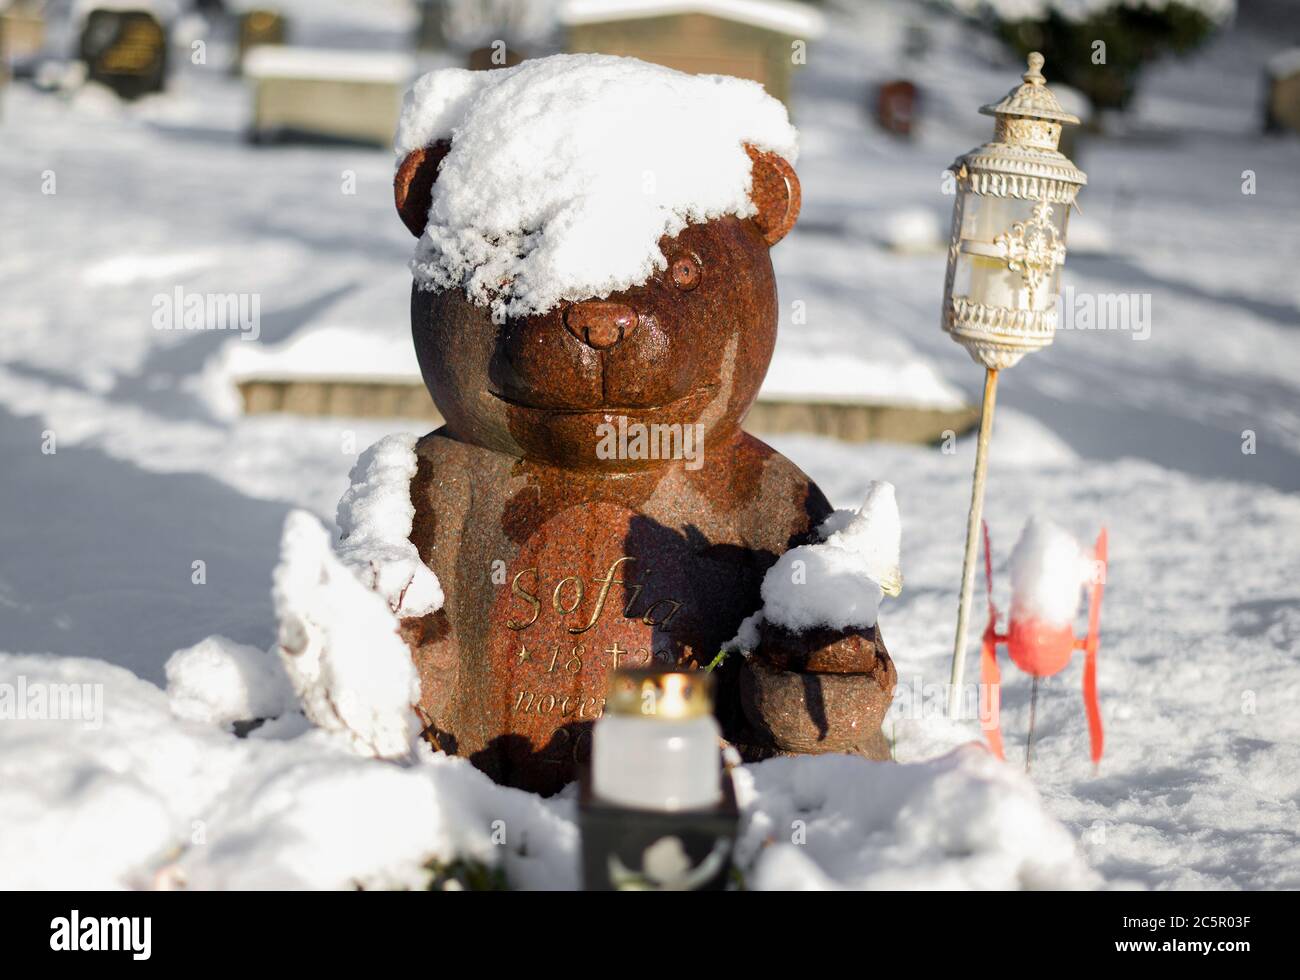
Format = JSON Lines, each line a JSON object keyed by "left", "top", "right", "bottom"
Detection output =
{"left": 737, "top": 745, "right": 1100, "bottom": 889}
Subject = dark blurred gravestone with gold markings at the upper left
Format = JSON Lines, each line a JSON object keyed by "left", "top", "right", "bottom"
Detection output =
{"left": 79, "top": 9, "right": 166, "bottom": 99}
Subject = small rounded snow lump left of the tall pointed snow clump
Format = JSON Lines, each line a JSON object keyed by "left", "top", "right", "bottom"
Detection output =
{"left": 165, "top": 637, "right": 296, "bottom": 728}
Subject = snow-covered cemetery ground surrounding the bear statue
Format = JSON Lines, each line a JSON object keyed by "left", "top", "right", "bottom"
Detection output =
{"left": 0, "top": 4, "right": 1300, "bottom": 888}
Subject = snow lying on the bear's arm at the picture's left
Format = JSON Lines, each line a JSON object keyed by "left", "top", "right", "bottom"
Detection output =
{"left": 337, "top": 433, "right": 443, "bottom": 616}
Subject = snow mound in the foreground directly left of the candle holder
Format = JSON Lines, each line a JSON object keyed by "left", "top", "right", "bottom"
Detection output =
{"left": 178, "top": 740, "right": 577, "bottom": 889}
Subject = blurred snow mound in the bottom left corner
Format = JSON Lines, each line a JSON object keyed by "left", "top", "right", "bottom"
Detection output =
{"left": 0, "top": 654, "right": 237, "bottom": 890}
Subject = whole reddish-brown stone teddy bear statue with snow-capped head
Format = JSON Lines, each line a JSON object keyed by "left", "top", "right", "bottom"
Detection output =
{"left": 384, "top": 56, "right": 896, "bottom": 793}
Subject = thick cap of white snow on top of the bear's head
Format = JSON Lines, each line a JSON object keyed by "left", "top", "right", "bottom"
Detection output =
{"left": 395, "top": 55, "right": 798, "bottom": 322}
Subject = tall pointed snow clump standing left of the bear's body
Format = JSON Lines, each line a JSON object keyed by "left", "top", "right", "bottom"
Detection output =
{"left": 272, "top": 511, "right": 420, "bottom": 758}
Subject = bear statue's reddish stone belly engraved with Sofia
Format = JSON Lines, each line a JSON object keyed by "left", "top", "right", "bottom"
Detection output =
{"left": 443, "top": 502, "right": 770, "bottom": 793}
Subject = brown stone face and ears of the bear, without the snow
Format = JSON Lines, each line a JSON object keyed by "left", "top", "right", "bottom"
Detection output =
{"left": 394, "top": 139, "right": 800, "bottom": 471}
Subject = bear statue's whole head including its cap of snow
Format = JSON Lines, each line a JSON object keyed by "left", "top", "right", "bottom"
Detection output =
{"left": 395, "top": 55, "right": 800, "bottom": 469}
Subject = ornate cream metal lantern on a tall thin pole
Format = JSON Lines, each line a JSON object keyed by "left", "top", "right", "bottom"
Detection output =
{"left": 943, "top": 51, "right": 1088, "bottom": 716}
